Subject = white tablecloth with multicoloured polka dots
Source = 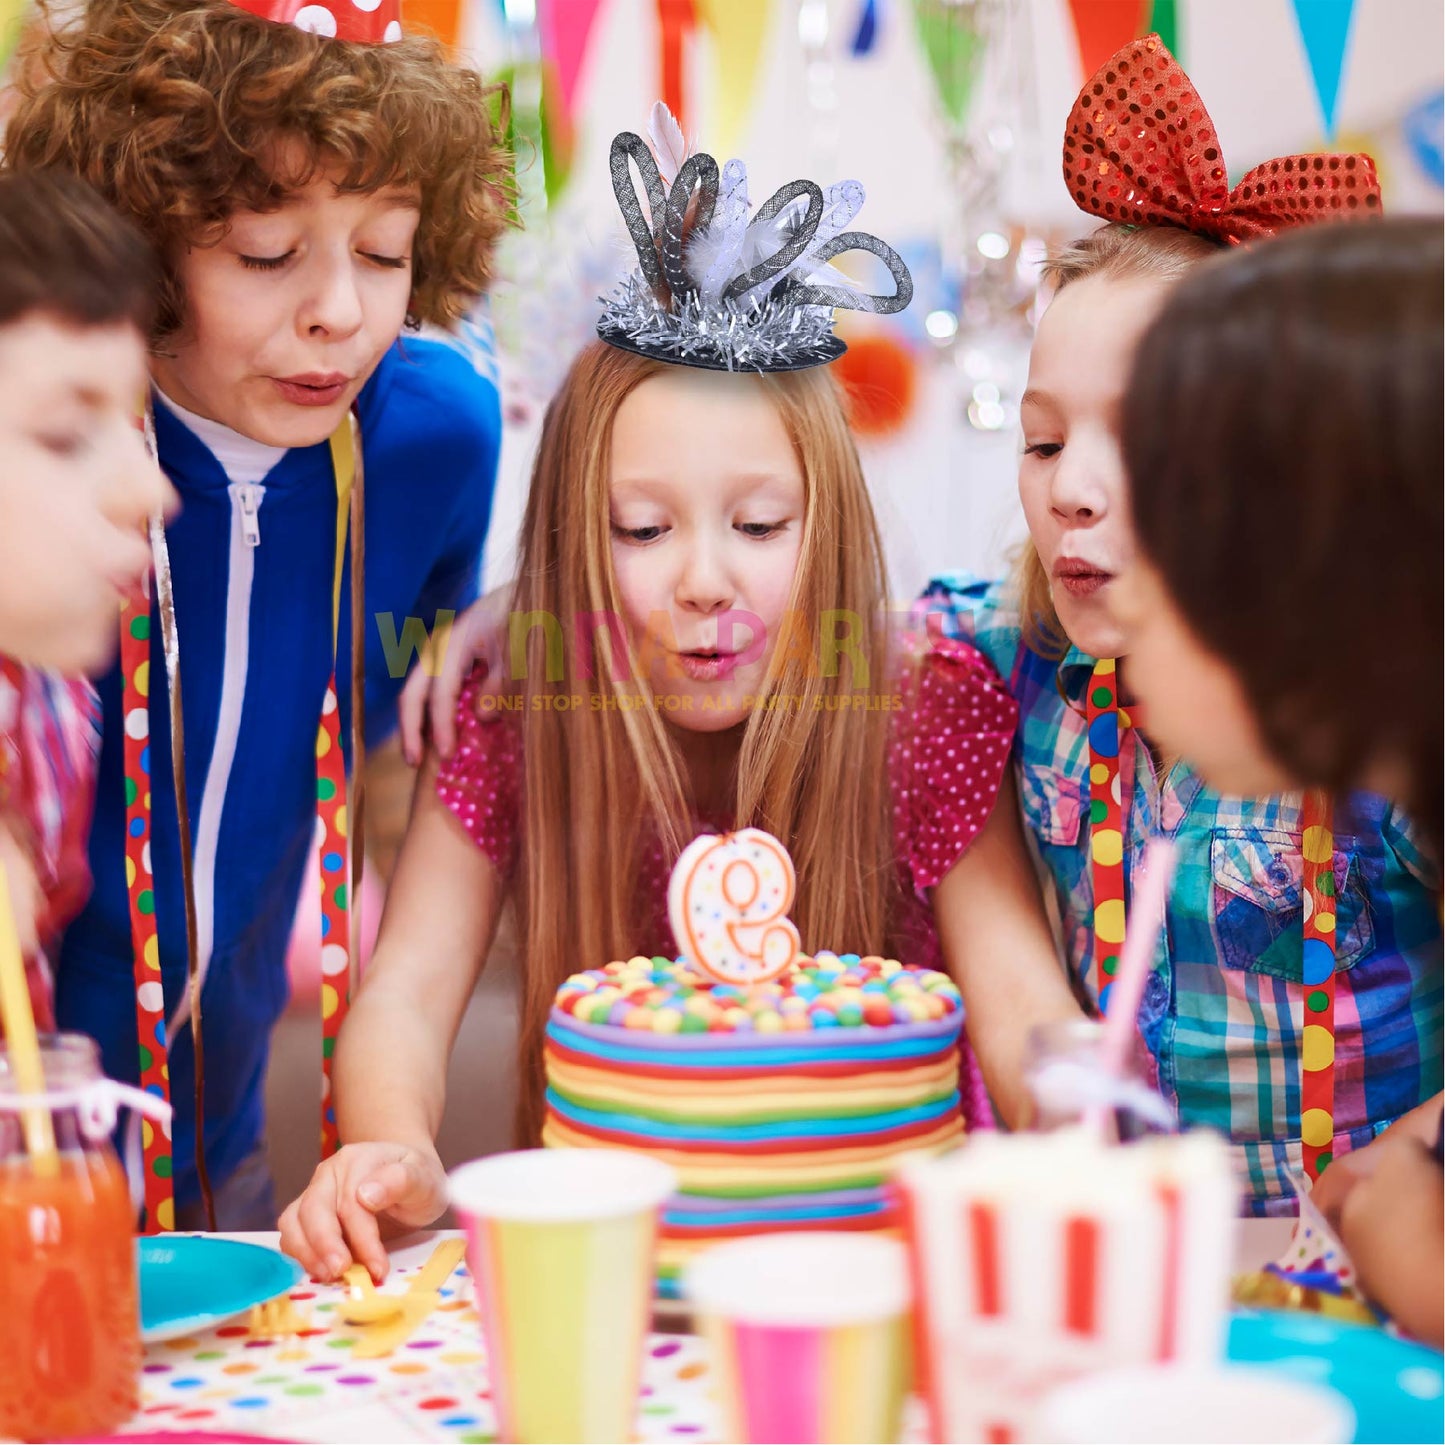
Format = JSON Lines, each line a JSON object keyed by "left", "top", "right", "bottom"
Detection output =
{"left": 130, "top": 1235, "right": 715, "bottom": 1442}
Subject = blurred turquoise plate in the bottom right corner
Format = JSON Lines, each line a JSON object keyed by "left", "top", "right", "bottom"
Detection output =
{"left": 1230, "top": 1309, "right": 1445, "bottom": 1445}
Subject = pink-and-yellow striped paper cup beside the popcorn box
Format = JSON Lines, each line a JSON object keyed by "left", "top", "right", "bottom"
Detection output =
{"left": 685, "top": 1231, "right": 909, "bottom": 1445}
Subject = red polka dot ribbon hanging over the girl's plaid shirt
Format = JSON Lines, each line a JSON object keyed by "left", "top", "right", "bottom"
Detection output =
{"left": 1085, "top": 659, "right": 1335, "bottom": 1179}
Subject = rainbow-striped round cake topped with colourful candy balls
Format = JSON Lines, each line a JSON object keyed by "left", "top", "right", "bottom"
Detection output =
{"left": 542, "top": 954, "right": 962, "bottom": 1293}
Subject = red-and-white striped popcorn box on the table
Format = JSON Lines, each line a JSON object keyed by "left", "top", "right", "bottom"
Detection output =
{"left": 899, "top": 1130, "right": 1235, "bottom": 1441}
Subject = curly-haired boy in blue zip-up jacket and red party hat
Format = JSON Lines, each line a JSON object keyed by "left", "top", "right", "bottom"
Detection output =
{"left": 6, "top": 0, "right": 512, "bottom": 1228}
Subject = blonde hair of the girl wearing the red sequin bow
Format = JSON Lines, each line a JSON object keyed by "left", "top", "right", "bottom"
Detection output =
{"left": 1013, "top": 221, "right": 1222, "bottom": 659}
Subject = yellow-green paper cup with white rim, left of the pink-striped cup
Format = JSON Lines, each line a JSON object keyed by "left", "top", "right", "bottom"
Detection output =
{"left": 449, "top": 1149, "right": 678, "bottom": 1445}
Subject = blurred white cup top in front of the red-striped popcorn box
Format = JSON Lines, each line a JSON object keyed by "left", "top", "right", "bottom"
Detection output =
{"left": 1030, "top": 1366, "right": 1355, "bottom": 1445}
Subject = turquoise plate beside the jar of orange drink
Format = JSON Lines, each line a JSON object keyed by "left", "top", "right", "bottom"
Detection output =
{"left": 137, "top": 1234, "right": 306, "bottom": 1344}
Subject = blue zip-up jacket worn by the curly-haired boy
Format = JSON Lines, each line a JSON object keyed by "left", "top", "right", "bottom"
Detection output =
{"left": 56, "top": 337, "right": 501, "bottom": 1205}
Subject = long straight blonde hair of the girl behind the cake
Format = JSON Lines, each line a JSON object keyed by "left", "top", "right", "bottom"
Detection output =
{"left": 513, "top": 342, "right": 896, "bottom": 1143}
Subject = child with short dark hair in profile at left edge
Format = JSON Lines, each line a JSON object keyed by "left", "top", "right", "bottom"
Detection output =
{"left": 0, "top": 175, "right": 169, "bottom": 1029}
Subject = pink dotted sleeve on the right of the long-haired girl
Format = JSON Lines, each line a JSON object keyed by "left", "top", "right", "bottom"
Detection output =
{"left": 890, "top": 637, "right": 1019, "bottom": 902}
